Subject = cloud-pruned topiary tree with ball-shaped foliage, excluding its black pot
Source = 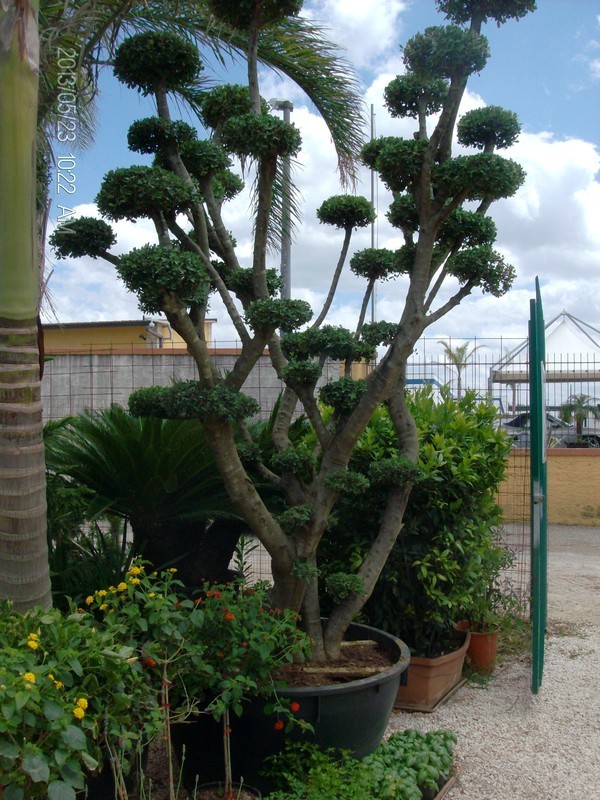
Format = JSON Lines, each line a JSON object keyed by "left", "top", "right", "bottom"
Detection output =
{"left": 53, "top": 0, "right": 535, "bottom": 756}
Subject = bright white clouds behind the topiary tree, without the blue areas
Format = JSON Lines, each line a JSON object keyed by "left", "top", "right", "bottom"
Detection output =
{"left": 44, "top": 0, "right": 600, "bottom": 350}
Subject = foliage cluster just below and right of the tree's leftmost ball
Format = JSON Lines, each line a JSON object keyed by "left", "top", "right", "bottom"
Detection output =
{"left": 117, "top": 245, "right": 208, "bottom": 314}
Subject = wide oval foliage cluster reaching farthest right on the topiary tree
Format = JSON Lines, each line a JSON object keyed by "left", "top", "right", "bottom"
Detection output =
{"left": 432, "top": 153, "right": 525, "bottom": 200}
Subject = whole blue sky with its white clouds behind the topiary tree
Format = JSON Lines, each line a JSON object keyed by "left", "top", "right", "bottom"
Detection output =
{"left": 45, "top": 0, "right": 600, "bottom": 350}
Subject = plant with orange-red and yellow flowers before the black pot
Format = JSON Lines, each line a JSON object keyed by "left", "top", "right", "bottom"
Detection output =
{"left": 85, "top": 560, "right": 309, "bottom": 797}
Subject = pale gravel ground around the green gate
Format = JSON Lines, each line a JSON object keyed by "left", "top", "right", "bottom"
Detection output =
{"left": 388, "top": 526, "right": 600, "bottom": 800}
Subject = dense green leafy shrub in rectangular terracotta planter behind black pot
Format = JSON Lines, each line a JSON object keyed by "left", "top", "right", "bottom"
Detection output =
{"left": 322, "top": 388, "right": 510, "bottom": 708}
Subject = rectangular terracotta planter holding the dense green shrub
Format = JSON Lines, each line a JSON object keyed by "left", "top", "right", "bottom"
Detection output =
{"left": 394, "top": 631, "right": 471, "bottom": 711}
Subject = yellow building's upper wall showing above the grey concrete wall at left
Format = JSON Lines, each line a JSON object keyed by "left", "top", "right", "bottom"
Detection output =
{"left": 44, "top": 320, "right": 213, "bottom": 353}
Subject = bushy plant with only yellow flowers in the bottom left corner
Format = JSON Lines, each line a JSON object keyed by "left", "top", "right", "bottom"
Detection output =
{"left": 0, "top": 602, "right": 161, "bottom": 800}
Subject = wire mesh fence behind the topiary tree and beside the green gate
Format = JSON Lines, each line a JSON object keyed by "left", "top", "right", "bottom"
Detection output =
{"left": 42, "top": 337, "right": 600, "bottom": 598}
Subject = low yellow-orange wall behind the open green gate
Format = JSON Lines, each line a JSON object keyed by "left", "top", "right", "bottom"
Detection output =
{"left": 500, "top": 447, "right": 600, "bottom": 525}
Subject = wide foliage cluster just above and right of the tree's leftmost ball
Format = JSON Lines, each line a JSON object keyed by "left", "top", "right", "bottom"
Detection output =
{"left": 96, "top": 166, "right": 196, "bottom": 220}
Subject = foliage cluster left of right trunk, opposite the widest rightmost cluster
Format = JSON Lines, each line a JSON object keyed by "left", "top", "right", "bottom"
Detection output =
{"left": 362, "top": 136, "right": 427, "bottom": 192}
